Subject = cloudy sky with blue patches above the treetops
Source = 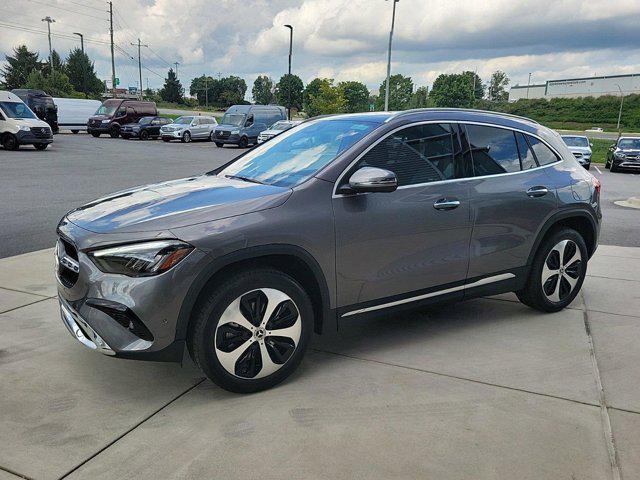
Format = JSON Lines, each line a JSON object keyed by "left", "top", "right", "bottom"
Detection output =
{"left": 0, "top": 0, "right": 640, "bottom": 95}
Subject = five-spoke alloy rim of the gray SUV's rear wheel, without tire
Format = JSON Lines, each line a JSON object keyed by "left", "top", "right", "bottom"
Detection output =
{"left": 541, "top": 240, "right": 582, "bottom": 303}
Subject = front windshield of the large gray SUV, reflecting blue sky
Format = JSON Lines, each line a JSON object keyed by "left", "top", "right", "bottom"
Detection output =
{"left": 218, "top": 119, "right": 378, "bottom": 187}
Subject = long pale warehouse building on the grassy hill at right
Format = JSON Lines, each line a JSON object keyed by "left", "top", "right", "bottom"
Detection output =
{"left": 509, "top": 73, "right": 640, "bottom": 102}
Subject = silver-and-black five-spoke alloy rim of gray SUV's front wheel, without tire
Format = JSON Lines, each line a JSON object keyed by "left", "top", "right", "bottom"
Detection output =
{"left": 214, "top": 288, "right": 302, "bottom": 378}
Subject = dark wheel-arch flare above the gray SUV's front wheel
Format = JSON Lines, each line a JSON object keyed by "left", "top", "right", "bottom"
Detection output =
{"left": 175, "top": 244, "right": 335, "bottom": 340}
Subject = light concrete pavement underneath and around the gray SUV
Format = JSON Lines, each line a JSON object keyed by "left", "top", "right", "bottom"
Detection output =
{"left": 0, "top": 245, "right": 640, "bottom": 480}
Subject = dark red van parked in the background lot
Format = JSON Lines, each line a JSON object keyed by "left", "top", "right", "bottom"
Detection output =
{"left": 87, "top": 98, "right": 158, "bottom": 138}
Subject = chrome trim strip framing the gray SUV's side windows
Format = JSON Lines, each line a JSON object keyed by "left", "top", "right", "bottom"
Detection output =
{"left": 331, "top": 120, "right": 564, "bottom": 199}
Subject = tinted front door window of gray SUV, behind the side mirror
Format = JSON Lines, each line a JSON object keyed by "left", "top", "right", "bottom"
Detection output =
{"left": 358, "top": 124, "right": 465, "bottom": 186}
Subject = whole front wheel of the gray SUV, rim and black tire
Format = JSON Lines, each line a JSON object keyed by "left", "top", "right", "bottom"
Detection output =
{"left": 189, "top": 269, "right": 313, "bottom": 393}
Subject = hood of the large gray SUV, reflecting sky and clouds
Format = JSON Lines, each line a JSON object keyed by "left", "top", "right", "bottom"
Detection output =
{"left": 67, "top": 174, "right": 292, "bottom": 233}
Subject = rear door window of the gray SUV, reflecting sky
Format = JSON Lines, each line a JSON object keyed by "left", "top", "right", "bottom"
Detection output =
{"left": 467, "top": 125, "right": 520, "bottom": 177}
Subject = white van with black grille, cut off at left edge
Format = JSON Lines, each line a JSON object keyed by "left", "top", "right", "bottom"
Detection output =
{"left": 0, "top": 90, "right": 53, "bottom": 150}
